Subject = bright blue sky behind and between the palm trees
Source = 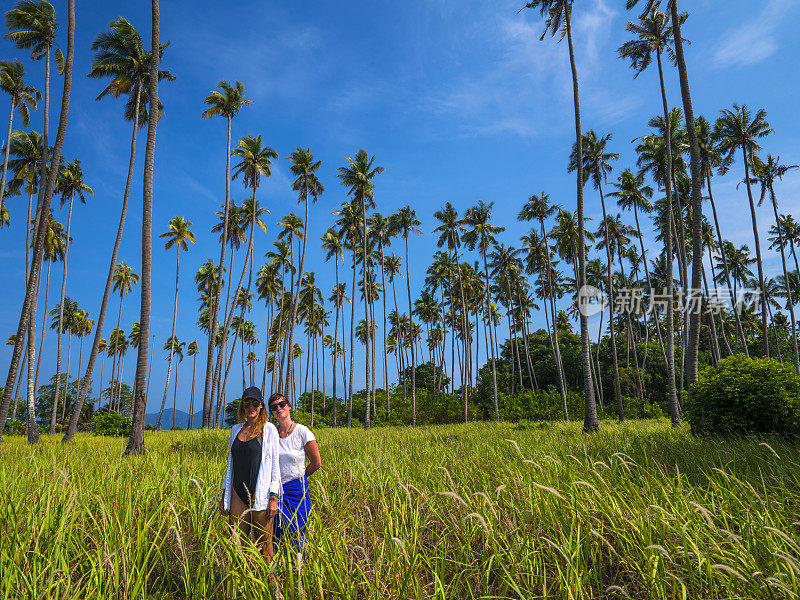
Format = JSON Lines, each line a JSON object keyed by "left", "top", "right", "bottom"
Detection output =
{"left": 0, "top": 0, "right": 800, "bottom": 411}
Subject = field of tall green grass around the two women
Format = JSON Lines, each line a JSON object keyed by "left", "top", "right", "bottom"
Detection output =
{"left": 0, "top": 421, "right": 800, "bottom": 600}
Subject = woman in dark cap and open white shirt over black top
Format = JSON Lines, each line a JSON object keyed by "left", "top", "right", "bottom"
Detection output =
{"left": 219, "top": 387, "right": 281, "bottom": 558}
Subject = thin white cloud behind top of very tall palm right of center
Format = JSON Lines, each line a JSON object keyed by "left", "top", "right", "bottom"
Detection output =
{"left": 424, "top": 0, "right": 636, "bottom": 138}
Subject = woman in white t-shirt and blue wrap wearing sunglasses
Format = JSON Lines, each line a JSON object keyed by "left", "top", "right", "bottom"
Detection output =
{"left": 268, "top": 393, "right": 322, "bottom": 551}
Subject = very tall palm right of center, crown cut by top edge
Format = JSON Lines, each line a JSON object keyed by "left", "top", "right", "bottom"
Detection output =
{"left": 525, "top": 0, "right": 600, "bottom": 431}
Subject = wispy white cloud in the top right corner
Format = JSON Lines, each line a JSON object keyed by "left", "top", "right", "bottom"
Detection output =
{"left": 714, "top": 0, "right": 797, "bottom": 68}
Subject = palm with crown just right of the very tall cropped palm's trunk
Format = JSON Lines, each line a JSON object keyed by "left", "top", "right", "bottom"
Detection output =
{"left": 568, "top": 129, "right": 625, "bottom": 423}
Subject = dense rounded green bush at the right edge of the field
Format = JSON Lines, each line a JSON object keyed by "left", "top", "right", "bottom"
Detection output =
{"left": 686, "top": 355, "right": 800, "bottom": 435}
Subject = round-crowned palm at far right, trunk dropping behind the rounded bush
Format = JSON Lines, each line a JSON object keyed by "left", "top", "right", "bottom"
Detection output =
{"left": 714, "top": 104, "right": 772, "bottom": 356}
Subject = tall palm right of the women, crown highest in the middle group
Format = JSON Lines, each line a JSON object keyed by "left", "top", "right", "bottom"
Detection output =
{"left": 337, "top": 148, "right": 384, "bottom": 429}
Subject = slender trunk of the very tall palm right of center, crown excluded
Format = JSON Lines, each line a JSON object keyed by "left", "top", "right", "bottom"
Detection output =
{"left": 564, "top": 10, "right": 600, "bottom": 431}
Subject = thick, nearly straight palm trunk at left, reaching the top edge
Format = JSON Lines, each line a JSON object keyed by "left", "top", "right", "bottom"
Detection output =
{"left": 125, "top": 0, "right": 160, "bottom": 454}
